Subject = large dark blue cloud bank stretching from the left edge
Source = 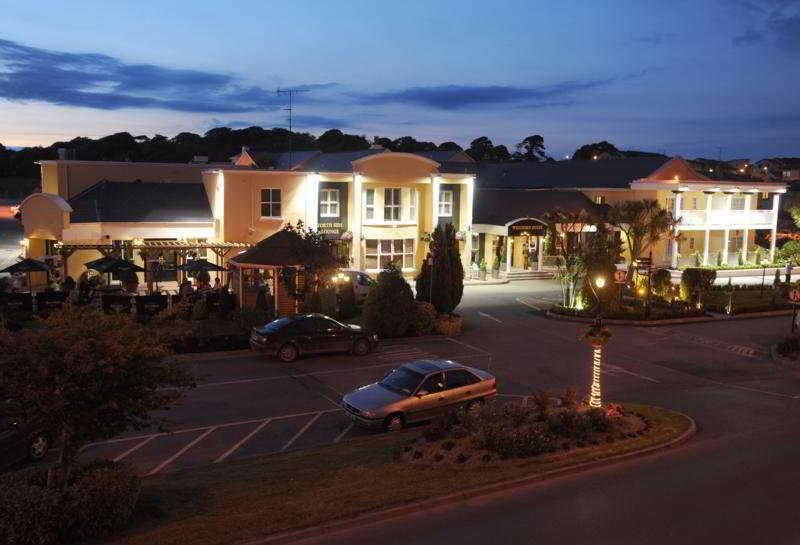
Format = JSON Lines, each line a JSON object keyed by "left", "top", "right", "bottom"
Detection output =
{"left": 0, "top": 39, "right": 335, "bottom": 113}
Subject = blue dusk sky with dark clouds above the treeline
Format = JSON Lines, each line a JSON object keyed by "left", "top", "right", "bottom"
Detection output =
{"left": 0, "top": 0, "right": 800, "bottom": 160}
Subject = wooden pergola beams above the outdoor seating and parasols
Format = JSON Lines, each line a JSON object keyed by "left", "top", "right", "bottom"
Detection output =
{"left": 55, "top": 239, "right": 253, "bottom": 288}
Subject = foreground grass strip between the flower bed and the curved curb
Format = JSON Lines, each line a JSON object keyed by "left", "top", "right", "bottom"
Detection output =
{"left": 105, "top": 405, "right": 690, "bottom": 545}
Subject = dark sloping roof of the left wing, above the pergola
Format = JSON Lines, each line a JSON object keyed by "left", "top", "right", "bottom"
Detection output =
{"left": 69, "top": 180, "right": 214, "bottom": 223}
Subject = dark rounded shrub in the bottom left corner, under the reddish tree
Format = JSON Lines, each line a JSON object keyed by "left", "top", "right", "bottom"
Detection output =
{"left": 0, "top": 461, "right": 141, "bottom": 545}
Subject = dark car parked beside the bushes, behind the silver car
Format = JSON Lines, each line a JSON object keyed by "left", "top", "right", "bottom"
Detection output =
{"left": 250, "top": 314, "right": 378, "bottom": 362}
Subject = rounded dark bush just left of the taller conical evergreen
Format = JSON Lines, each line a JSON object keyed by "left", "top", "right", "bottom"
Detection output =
{"left": 364, "top": 263, "right": 416, "bottom": 337}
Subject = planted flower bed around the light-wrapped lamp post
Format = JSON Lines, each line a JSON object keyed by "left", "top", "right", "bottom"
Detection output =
{"left": 403, "top": 398, "right": 650, "bottom": 466}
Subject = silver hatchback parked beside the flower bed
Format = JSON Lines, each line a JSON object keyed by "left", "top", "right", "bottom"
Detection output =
{"left": 342, "top": 360, "right": 497, "bottom": 430}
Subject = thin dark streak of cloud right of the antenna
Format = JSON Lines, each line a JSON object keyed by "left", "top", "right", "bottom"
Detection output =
{"left": 352, "top": 78, "right": 618, "bottom": 110}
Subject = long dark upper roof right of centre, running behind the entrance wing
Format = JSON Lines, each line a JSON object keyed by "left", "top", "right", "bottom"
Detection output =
{"left": 476, "top": 157, "right": 669, "bottom": 189}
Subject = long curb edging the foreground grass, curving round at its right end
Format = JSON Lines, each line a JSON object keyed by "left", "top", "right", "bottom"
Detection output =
{"left": 240, "top": 411, "right": 697, "bottom": 545}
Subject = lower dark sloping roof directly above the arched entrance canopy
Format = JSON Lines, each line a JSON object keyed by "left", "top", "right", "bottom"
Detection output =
{"left": 472, "top": 188, "right": 605, "bottom": 225}
